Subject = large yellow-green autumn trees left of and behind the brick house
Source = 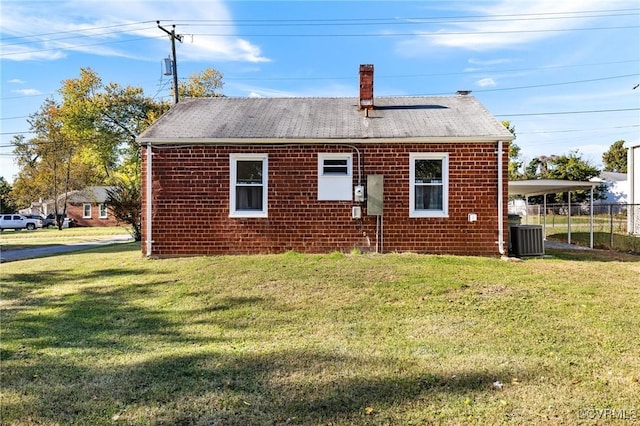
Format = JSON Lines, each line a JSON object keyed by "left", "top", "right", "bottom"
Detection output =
{"left": 11, "top": 68, "right": 223, "bottom": 231}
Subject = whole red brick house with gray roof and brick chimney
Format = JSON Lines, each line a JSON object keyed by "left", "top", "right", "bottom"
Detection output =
{"left": 137, "top": 65, "right": 513, "bottom": 256}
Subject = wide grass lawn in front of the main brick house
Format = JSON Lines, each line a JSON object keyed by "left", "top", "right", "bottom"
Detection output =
{"left": 0, "top": 243, "right": 640, "bottom": 425}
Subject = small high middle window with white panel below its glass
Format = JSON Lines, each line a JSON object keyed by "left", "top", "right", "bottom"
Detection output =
{"left": 318, "top": 153, "right": 353, "bottom": 201}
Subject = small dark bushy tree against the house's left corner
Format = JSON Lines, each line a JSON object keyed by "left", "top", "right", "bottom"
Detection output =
{"left": 106, "top": 177, "right": 142, "bottom": 241}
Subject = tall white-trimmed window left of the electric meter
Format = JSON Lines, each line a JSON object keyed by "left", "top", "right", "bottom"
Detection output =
{"left": 229, "top": 154, "right": 268, "bottom": 217}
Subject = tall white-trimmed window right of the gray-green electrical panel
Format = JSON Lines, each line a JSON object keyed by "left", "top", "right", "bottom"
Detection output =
{"left": 409, "top": 153, "right": 449, "bottom": 217}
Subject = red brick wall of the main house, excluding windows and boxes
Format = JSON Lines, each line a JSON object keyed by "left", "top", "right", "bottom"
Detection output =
{"left": 142, "top": 143, "right": 508, "bottom": 256}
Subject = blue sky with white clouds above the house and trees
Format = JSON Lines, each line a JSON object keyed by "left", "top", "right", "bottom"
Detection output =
{"left": 0, "top": 0, "right": 640, "bottom": 182}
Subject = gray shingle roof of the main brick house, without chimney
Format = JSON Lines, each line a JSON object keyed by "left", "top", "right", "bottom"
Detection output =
{"left": 138, "top": 95, "right": 512, "bottom": 143}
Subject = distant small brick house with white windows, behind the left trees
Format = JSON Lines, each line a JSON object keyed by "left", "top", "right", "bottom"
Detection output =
{"left": 41, "top": 186, "right": 118, "bottom": 226}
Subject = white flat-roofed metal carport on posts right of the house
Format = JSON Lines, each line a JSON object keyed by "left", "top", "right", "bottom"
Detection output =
{"left": 509, "top": 179, "right": 600, "bottom": 248}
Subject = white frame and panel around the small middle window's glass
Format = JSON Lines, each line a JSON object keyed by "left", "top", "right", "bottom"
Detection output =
{"left": 318, "top": 152, "right": 353, "bottom": 201}
